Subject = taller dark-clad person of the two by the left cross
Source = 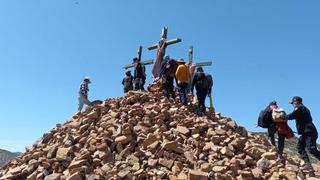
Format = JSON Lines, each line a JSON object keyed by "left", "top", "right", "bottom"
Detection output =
{"left": 133, "top": 57, "right": 146, "bottom": 91}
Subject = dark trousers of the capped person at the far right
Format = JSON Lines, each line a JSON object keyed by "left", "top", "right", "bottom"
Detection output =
{"left": 297, "top": 132, "right": 320, "bottom": 162}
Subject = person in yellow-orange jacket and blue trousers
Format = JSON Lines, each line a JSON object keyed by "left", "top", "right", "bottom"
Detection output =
{"left": 176, "top": 59, "right": 190, "bottom": 105}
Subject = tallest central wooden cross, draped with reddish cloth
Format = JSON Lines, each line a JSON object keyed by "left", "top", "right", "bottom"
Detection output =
{"left": 148, "top": 26, "right": 182, "bottom": 78}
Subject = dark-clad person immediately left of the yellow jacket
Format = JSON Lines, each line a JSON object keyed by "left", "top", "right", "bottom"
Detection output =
{"left": 160, "top": 59, "right": 178, "bottom": 99}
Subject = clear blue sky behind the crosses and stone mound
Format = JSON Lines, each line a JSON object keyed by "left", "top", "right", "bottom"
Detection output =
{"left": 0, "top": 0, "right": 320, "bottom": 151}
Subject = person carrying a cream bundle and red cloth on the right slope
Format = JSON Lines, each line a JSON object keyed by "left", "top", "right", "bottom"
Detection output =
{"left": 270, "top": 101, "right": 294, "bottom": 160}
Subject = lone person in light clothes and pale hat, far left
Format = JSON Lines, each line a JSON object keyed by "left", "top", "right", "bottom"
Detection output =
{"left": 78, "top": 77, "right": 91, "bottom": 113}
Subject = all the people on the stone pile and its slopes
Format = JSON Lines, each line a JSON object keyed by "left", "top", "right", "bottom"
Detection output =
{"left": 78, "top": 60, "right": 320, "bottom": 169}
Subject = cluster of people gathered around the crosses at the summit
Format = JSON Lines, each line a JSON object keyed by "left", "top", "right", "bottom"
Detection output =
{"left": 122, "top": 56, "right": 213, "bottom": 114}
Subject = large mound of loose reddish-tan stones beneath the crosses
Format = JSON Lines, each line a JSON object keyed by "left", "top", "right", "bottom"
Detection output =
{"left": 0, "top": 85, "right": 320, "bottom": 180}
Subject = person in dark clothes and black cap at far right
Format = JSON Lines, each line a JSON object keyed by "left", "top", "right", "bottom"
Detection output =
{"left": 286, "top": 96, "right": 320, "bottom": 169}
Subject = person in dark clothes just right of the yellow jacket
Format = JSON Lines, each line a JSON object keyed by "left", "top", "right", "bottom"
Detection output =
{"left": 191, "top": 67, "right": 213, "bottom": 116}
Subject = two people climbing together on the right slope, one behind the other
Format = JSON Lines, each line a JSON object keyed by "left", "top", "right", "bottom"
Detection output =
{"left": 258, "top": 96, "right": 320, "bottom": 169}
